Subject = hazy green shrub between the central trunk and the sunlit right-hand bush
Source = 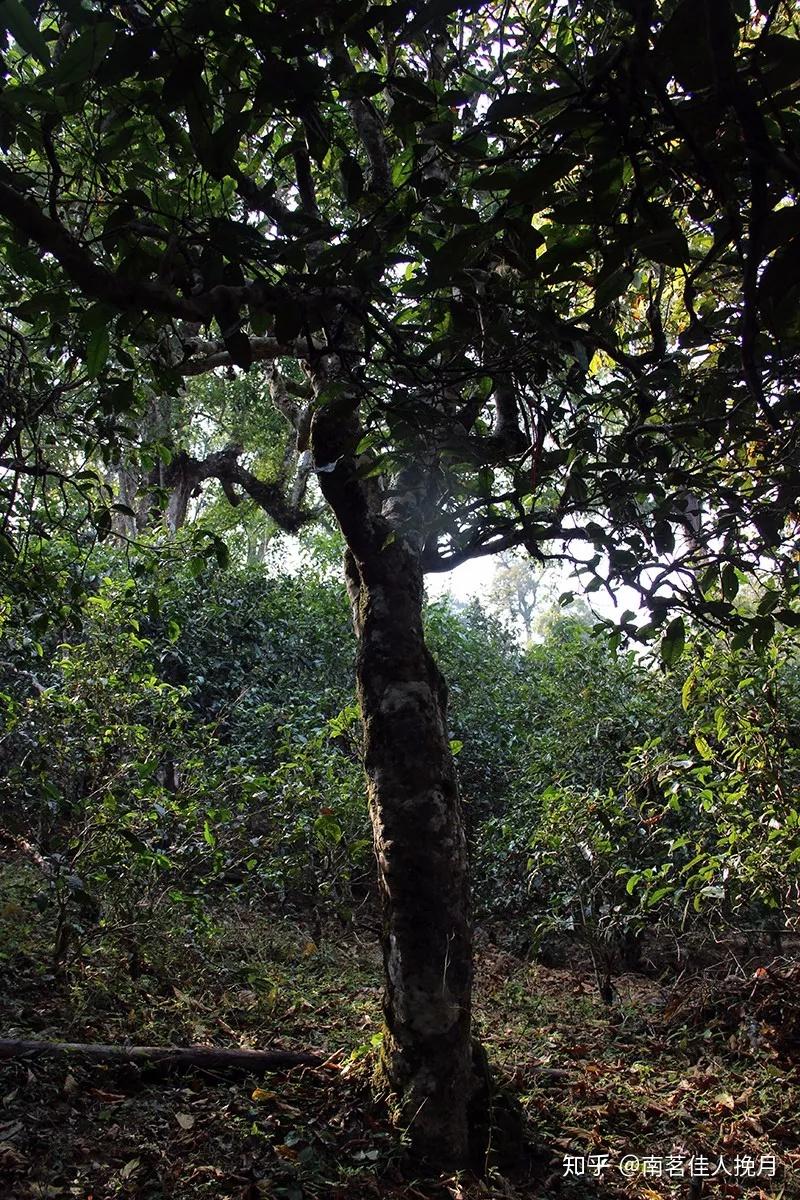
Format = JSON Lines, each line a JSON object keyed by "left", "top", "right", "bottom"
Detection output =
{"left": 475, "top": 619, "right": 680, "bottom": 916}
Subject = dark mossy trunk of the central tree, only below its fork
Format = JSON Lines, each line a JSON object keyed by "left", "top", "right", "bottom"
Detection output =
{"left": 347, "top": 538, "right": 476, "bottom": 1166}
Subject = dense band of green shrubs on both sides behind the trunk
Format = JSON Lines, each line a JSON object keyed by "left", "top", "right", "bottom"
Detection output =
{"left": 0, "top": 544, "right": 800, "bottom": 984}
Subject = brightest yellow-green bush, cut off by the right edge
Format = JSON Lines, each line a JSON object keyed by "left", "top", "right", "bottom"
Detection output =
{"left": 625, "top": 637, "right": 800, "bottom": 934}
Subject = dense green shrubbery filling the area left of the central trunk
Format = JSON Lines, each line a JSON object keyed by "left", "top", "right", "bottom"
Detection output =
{"left": 1, "top": 554, "right": 368, "bottom": 954}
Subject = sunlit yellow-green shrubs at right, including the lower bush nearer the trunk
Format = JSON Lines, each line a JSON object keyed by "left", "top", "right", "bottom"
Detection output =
{"left": 513, "top": 637, "right": 800, "bottom": 994}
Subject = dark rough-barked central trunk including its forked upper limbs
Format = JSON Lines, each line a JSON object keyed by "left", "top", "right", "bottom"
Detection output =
{"left": 311, "top": 353, "right": 479, "bottom": 1168}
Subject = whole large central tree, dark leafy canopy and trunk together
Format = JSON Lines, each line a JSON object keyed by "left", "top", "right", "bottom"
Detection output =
{"left": 0, "top": 0, "right": 800, "bottom": 1163}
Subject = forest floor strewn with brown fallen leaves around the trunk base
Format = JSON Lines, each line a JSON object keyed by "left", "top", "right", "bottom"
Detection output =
{"left": 0, "top": 869, "right": 800, "bottom": 1200}
